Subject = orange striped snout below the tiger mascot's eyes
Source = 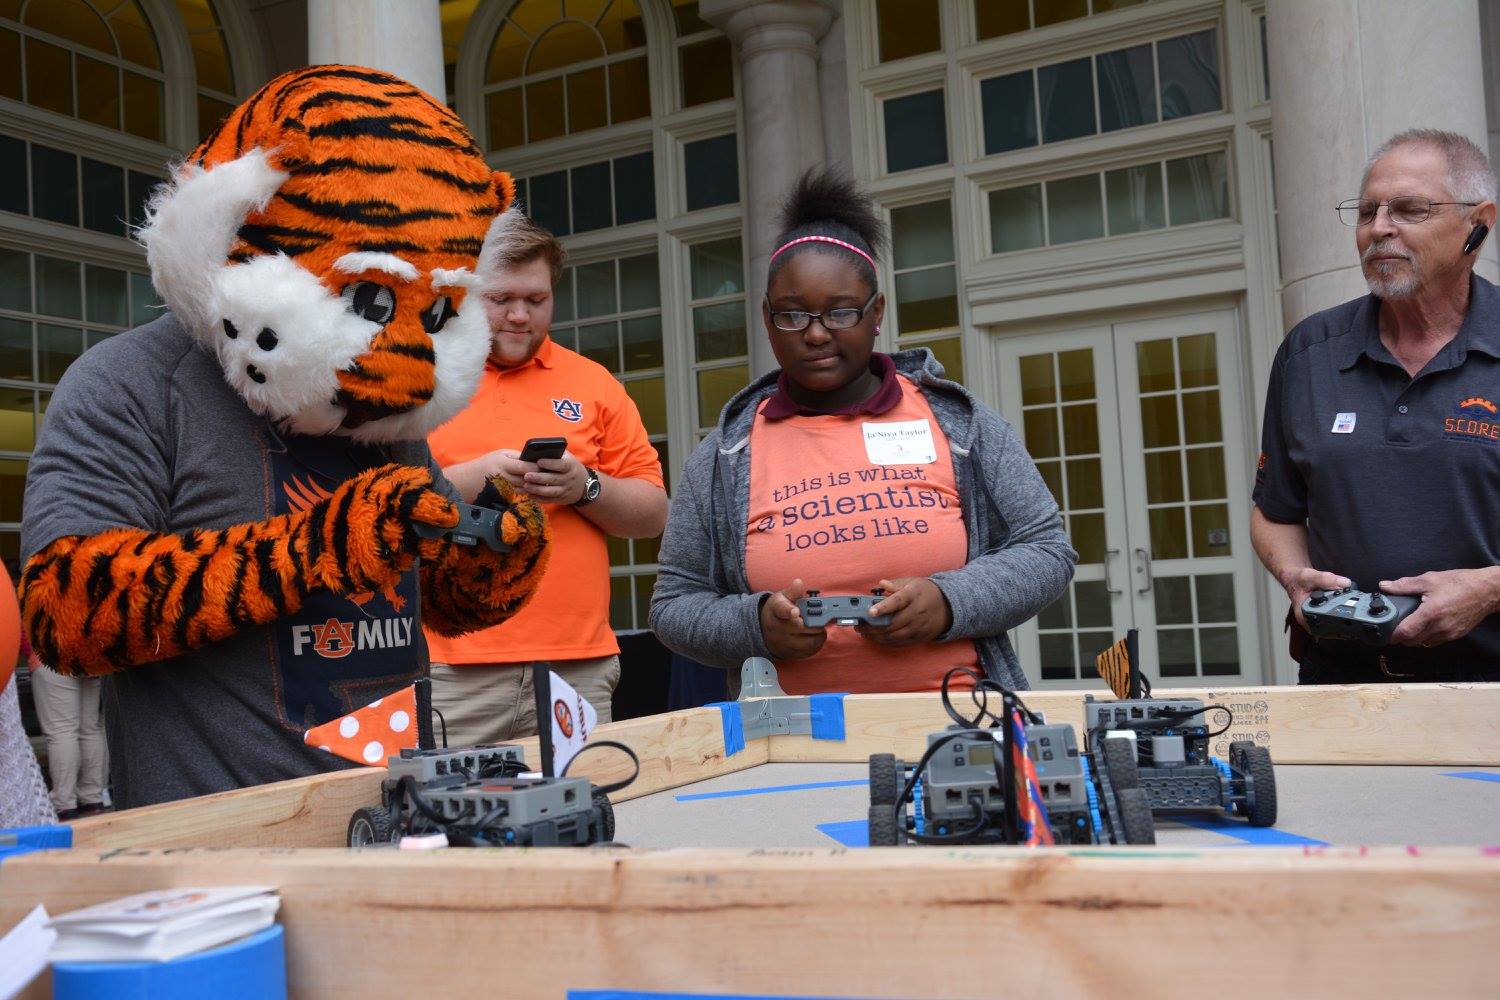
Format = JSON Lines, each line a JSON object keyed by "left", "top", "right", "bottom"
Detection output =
{"left": 333, "top": 310, "right": 437, "bottom": 429}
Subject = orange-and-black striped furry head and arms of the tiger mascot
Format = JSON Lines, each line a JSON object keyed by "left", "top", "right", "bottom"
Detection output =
{"left": 21, "top": 66, "right": 548, "bottom": 675}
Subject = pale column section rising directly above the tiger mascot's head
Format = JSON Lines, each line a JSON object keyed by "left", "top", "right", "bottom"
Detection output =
{"left": 308, "top": 0, "right": 447, "bottom": 103}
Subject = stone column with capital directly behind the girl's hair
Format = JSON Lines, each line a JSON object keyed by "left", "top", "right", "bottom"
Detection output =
{"left": 699, "top": 0, "right": 834, "bottom": 376}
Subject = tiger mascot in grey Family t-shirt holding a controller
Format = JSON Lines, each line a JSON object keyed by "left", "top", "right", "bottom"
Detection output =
{"left": 21, "top": 66, "right": 546, "bottom": 807}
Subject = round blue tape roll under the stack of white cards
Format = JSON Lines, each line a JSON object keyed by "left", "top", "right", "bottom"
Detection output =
{"left": 53, "top": 924, "right": 287, "bottom": 1000}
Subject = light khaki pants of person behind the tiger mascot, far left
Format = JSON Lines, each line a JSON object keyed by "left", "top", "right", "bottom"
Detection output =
{"left": 32, "top": 667, "right": 108, "bottom": 813}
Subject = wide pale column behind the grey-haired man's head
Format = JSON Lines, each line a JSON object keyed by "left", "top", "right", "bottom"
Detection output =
{"left": 1266, "top": 0, "right": 1500, "bottom": 330}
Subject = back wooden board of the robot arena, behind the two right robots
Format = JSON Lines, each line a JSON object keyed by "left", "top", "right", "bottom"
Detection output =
{"left": 770, "top": 684, "right": 1500, "bottom": 765}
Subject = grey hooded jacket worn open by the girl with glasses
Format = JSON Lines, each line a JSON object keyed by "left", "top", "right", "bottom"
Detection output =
{"left": 651, "top": 349, "right": 1079, "bottom": 697}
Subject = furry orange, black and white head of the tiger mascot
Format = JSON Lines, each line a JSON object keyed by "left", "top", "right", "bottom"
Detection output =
{"left": 140, "top": 66, "right": 515, "bottom": 441}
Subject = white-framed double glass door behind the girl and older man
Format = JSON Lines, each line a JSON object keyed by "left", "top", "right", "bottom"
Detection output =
{"left": 996, "top": 312, "right": 1262, "bottom": 687}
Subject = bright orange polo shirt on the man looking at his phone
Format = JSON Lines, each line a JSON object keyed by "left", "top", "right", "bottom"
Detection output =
{"left": 428, "top": 337, "right": 662, "bottom": 666}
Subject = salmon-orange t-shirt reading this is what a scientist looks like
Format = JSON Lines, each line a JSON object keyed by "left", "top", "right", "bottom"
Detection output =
{"left": 746, "top": 378, "right": 980, "bottom": 694}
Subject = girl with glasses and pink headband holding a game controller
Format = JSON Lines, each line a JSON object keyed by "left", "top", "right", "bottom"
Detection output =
{"left": 651, "top": 167, "right": 1076, "bottom": 693}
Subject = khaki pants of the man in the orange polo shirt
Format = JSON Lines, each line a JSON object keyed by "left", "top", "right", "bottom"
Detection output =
{"left": 432, "top": 657, "right": 620, "bottom": 747}
